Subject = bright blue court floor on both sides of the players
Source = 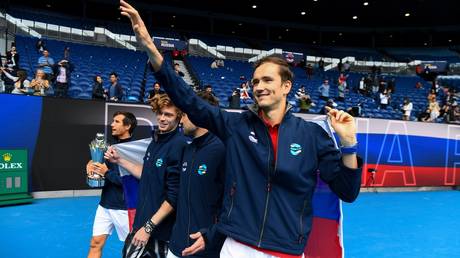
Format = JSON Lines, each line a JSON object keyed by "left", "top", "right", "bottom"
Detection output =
{"left": 0, "top": 191, "right": 460, "bottom": 258}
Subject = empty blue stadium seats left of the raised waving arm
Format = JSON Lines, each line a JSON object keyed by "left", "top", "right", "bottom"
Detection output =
{"left": 16, "top": 36, "right": 147, "bottom": 101}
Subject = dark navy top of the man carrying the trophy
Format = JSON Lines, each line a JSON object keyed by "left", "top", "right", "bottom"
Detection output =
{"left": 99, "top": 138, "right": 131, "bottom": 210}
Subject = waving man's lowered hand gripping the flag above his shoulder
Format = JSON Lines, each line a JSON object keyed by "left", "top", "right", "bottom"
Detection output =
{"left": 326, "top": 107, "right": 357, "bottom": 146}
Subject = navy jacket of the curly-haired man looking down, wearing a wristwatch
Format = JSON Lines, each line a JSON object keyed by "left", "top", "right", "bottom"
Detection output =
{"left": 133, "top": 128, "right": 187, "bottom": 241}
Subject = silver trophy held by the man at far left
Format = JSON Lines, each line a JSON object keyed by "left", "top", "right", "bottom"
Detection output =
{"left": 86, "top": 133, "right": 108, "bottom": 188}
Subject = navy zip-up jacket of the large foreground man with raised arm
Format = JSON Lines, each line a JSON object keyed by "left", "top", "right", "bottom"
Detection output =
{"left": 155, "top": 62, "right": 362, "bottom": 255}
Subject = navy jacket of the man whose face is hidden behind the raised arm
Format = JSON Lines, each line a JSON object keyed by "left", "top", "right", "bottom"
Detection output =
{"left": 169, "top": 132, "right": 225, "bottom": 258}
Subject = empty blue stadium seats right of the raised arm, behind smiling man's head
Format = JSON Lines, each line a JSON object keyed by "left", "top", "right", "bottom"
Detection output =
{"left": 188, "top": 57, "right": 430, "bottom": 119}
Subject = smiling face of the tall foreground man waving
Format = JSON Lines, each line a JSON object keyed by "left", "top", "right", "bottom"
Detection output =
{"left": 252, "top": 63, "right": 292, "bottom": 108}
